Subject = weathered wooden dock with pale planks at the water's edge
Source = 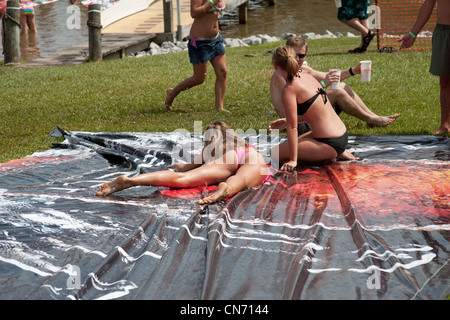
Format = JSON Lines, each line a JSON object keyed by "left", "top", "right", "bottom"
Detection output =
{"left": 16, "top": 0, "right": 274, "bottom": 68}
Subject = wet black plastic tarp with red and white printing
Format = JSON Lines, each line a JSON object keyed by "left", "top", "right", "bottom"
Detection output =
{"left": 0, "top": 129, "right": 450, "bottom": 301}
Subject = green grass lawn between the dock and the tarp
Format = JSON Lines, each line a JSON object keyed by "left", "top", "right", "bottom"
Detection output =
{"left": 0, "top": 38, "right": 440, "bottom": 163}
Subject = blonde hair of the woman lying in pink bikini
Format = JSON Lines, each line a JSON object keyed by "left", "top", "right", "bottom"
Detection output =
{"left": 202, "top": 121, "right": 246, "bottom": 162}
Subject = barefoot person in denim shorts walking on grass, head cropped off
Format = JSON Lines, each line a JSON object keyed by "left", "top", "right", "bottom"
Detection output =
{"left": 165, "top": 0, "right": 227, "bottom": 111}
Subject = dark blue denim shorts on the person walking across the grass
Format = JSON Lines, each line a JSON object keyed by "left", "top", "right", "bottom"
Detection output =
{"left": 188, "top": 33, "right": 225, "bottom": 64}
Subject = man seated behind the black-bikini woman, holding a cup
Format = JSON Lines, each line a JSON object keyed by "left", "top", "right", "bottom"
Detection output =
{"left": 270, "top": 36, "right": 400, "bottom": 130}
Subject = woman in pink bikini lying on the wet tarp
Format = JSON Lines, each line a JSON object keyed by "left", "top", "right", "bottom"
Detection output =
{"left": 97, "top": 122, "right": 270, "bottom": 204}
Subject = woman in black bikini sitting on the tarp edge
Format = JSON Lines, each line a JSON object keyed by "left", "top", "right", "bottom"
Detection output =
{"left": 271, "top": 45, "right": 356, "bottom": 171}
